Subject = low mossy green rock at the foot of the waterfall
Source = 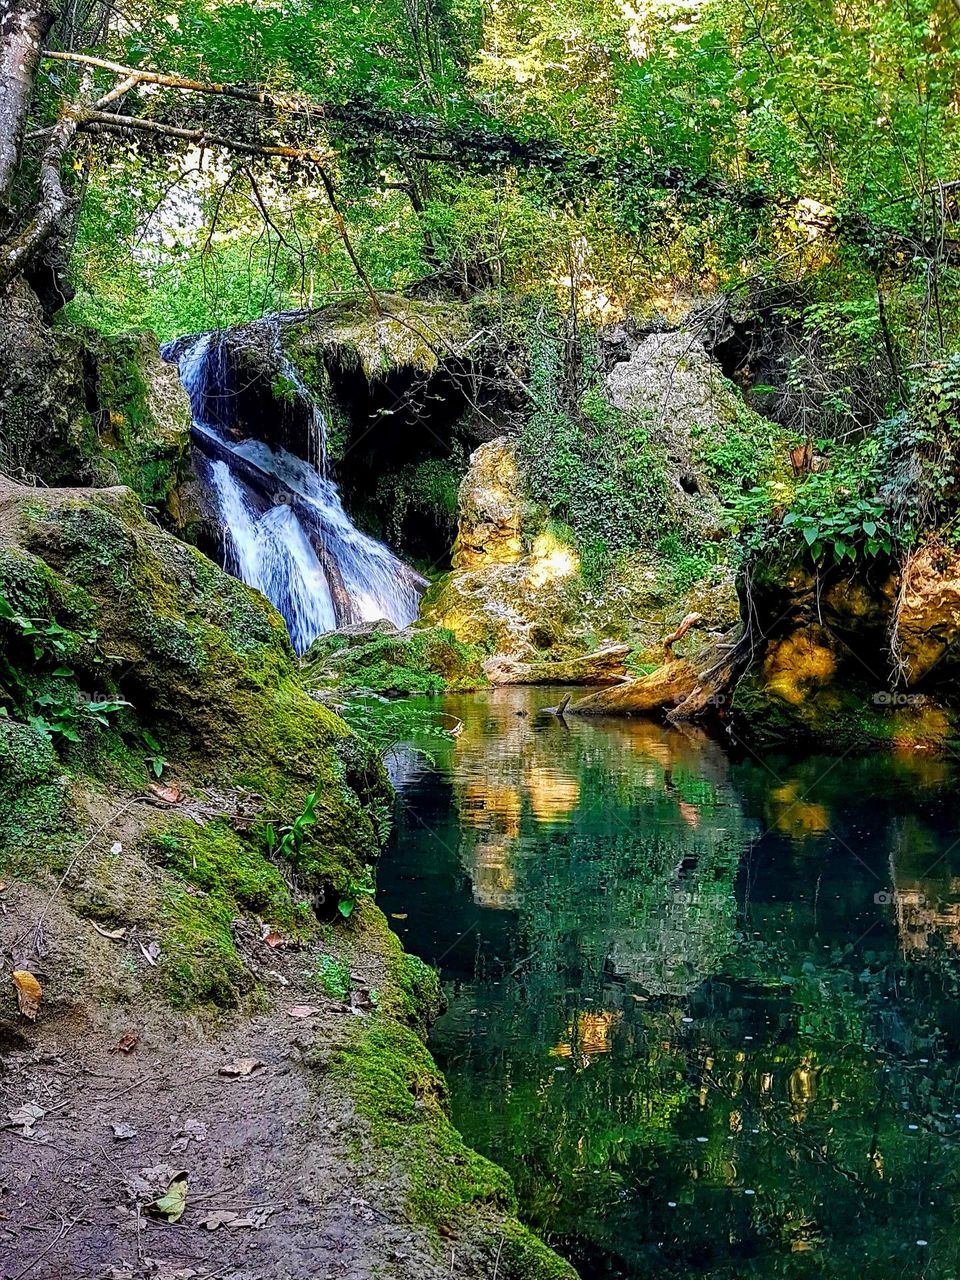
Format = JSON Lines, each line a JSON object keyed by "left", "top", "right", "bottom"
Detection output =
{"left": 301, "top": 618, "right": 486, "bottom": 694}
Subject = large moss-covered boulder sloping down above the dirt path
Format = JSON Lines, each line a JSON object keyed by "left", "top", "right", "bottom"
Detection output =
{"left": 0, "top": 480, "right": 387, "bottom": 911}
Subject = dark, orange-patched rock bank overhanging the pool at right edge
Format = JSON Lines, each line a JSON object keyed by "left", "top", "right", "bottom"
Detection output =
{"left": 732, "top": 547, "right": 960, "bottom": 749}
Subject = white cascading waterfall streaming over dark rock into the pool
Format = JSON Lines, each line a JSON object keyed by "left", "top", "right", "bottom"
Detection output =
{"left": 164, "top": 332, "right": 426, "bottom": 653}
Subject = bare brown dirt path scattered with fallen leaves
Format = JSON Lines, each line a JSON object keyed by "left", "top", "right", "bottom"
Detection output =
{"left": 0, "top": 890, "right": 463, "bottom": 1280}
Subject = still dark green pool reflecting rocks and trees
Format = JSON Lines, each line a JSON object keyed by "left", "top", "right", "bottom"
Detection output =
{"left": 380, "top": 689, "right": 960, "bottom": 1280}
